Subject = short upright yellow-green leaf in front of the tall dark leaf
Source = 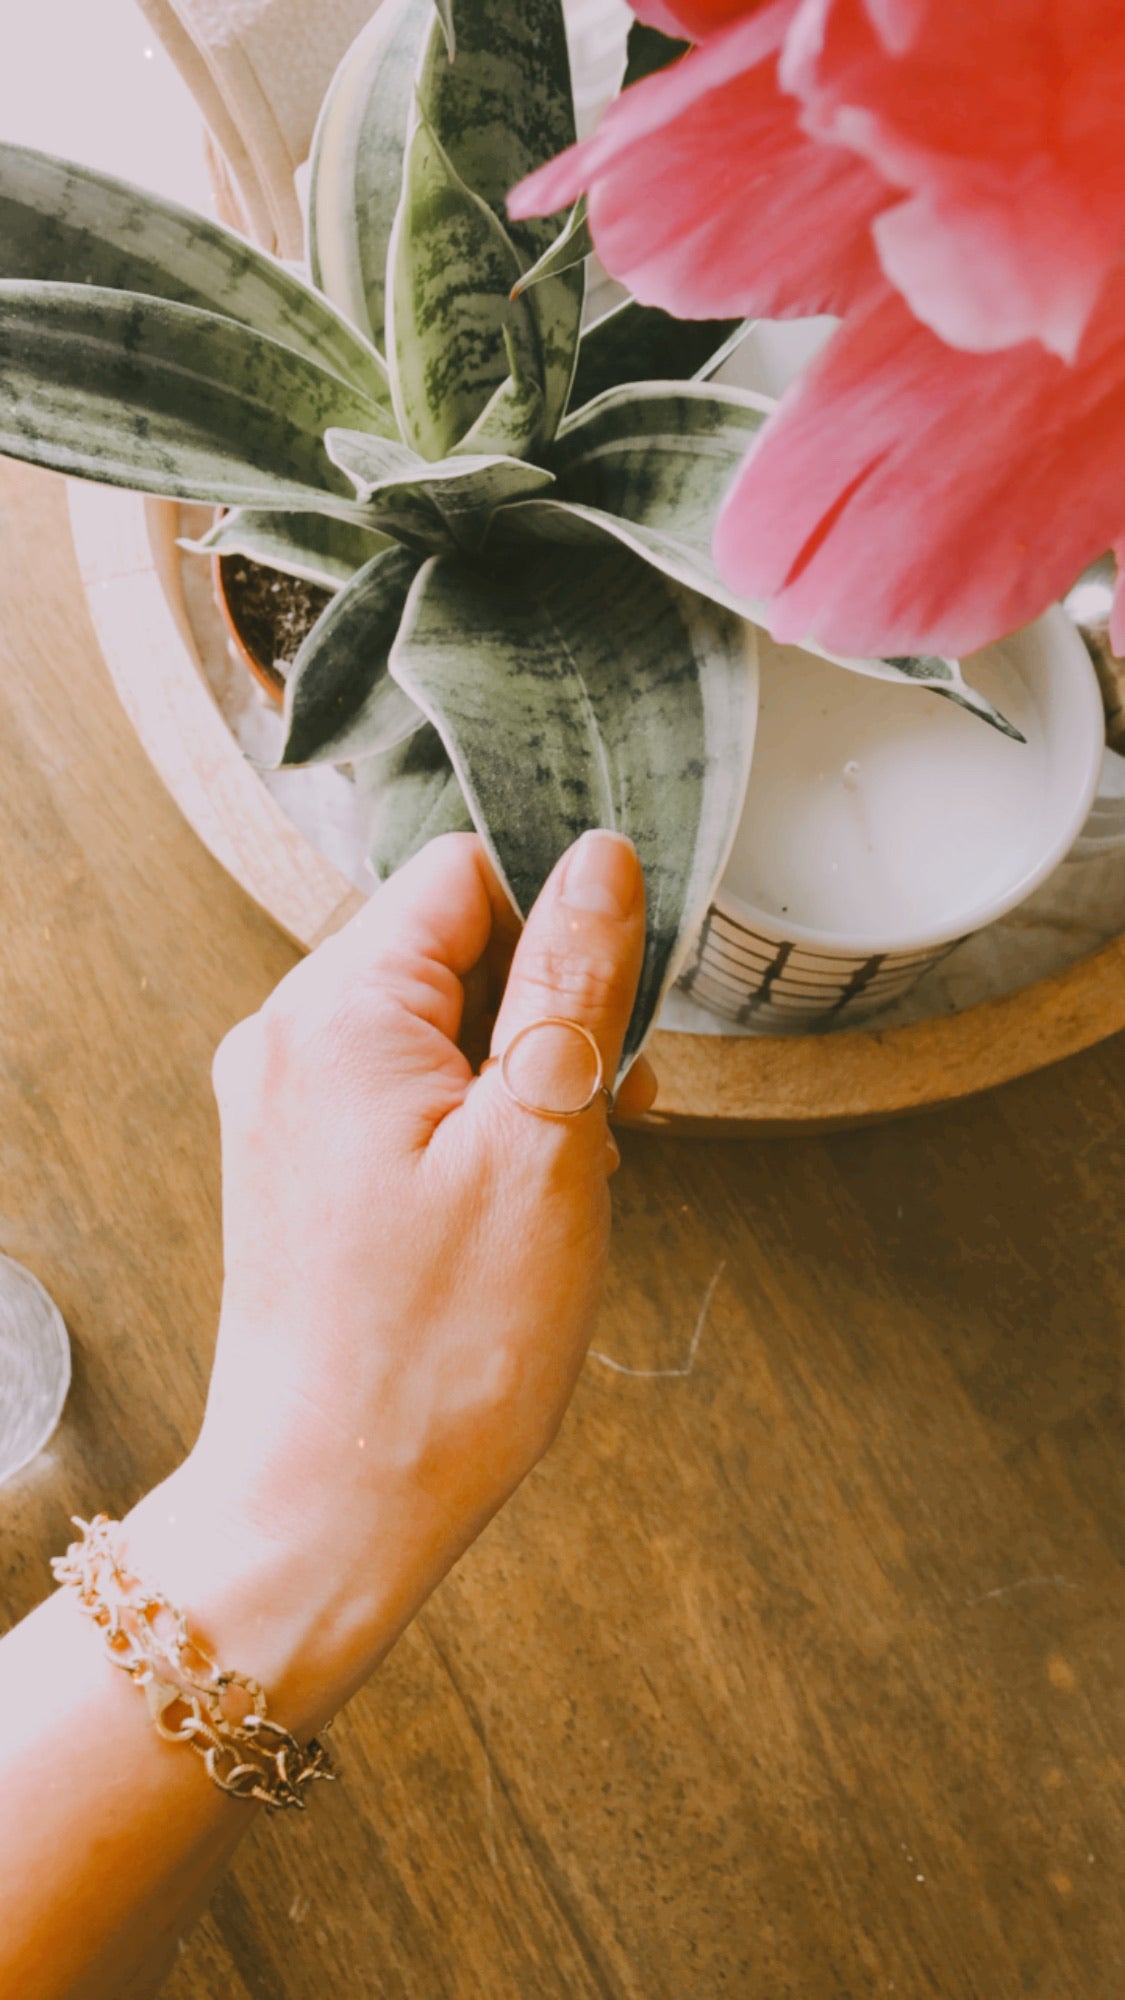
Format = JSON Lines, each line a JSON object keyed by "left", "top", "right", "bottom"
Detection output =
{"left": 388, "top": 114, "right": 540, "bottom": 460}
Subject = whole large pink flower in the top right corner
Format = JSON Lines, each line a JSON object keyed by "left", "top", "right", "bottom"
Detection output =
{"left": 512, "top": 0, "right": 1125, "bottom": 652}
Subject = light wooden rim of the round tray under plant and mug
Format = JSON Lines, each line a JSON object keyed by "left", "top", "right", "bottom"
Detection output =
{"left": 70, "top": 482, "right": 1125, "bottom": 1138}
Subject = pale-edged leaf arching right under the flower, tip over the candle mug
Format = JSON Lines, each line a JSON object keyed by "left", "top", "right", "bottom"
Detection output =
{"left": 516, "top": 382, "right": 1019, "bottom": 736}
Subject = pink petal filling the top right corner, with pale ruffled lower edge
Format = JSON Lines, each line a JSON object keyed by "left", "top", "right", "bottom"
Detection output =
{"left": 781, "top": 0, "right": 1125, "bottom": 360}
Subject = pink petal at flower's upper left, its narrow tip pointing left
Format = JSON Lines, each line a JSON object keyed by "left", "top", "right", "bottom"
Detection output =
{"left": 508, "top": 0, "right": 887, "bottom": 320}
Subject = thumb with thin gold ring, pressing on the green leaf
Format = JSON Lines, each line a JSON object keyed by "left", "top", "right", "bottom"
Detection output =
{"left": 478, "top": 830, "right": 645, "bottom": 1130}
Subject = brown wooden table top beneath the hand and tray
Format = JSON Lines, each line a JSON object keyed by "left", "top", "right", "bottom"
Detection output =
{"left": 0, "top": 466, "right": 1125, "bottom": 2000}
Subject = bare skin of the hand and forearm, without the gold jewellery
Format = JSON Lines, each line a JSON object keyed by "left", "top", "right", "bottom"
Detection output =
{"left": 0, "top": 834, "right": 655, "bottom": 2000}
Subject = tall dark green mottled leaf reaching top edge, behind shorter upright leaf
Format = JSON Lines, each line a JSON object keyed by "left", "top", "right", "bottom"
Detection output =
{"left": 418, "top": 0, "right": 587, "bottom": 436}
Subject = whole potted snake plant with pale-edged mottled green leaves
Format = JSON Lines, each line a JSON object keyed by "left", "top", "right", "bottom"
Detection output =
{"left": 0, "top": 0, "right": 1003, "bottom": 1062}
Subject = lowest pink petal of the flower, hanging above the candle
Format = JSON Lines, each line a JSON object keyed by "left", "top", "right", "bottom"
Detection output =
{"left": 715, "top": 270, "right": 1125, "bottom": 654}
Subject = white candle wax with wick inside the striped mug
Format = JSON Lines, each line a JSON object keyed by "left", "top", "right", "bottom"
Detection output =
{"left": 725, "top": 632, "right": 1047, "bottom": 942}
